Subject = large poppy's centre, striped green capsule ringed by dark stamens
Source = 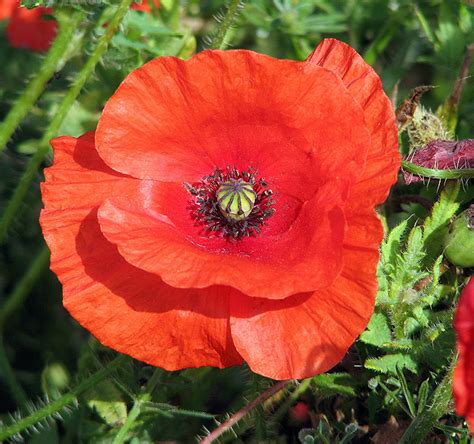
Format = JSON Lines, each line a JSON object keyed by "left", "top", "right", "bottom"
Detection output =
{"left": 184, "top": 166, "right": 275, "bottom": 240}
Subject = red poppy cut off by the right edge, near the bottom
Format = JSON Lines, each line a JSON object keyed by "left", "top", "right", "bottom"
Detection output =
{"left": 453, "top": 278, "right": 474, "bottom": 431}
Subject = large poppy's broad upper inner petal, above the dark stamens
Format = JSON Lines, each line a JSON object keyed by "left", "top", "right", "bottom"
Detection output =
{"left": 96, "top": 50, "right": 370, "bottom": 189}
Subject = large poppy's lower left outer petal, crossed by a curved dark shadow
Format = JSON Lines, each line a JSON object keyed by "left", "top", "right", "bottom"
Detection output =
{"left": 41, "top": 133, "right": 242, "bottom": 370}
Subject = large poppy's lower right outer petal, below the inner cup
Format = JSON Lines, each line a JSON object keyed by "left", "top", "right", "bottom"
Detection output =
{"left": 227, "top": 211, "right": 383, "bottom": 379}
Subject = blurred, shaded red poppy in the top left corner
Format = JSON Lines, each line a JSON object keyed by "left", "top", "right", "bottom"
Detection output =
{"left": 7, "top": 0, "right": 58, "bottom": 52}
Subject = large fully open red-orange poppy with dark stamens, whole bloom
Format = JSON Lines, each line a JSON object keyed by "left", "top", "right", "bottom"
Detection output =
{"left": 41, "top": 40, "right": 400, "bottom": 379}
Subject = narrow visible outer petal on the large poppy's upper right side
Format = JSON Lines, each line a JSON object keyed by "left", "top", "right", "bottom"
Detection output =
{"left": 307, "top": 39, "right": 400, "bottom": 211}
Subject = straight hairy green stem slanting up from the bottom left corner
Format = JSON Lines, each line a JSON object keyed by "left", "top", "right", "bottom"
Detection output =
{"left": 0, "top": 356, "right": 127, "bottom": 441}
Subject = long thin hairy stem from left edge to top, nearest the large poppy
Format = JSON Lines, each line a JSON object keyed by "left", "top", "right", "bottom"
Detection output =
{"left": 0, "top": 0, "right": 132, "bottom": 244}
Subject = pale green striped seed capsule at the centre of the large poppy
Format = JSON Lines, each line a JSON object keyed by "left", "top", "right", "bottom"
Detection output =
{"left": 216, "top": 179, "right": 257, "bottom": 221}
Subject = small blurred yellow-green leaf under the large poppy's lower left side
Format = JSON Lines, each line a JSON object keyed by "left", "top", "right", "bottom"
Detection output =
{"left": 84, "top": 380, "right": 127, "bottom": 426}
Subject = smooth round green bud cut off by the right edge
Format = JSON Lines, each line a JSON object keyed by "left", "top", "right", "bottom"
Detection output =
{"left": 445, "top": 205, "right": 474, "bottom": 268}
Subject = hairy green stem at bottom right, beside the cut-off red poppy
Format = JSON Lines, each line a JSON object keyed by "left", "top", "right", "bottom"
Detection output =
{"left": 400, "top": 355, "right": 457, "bottom": 444}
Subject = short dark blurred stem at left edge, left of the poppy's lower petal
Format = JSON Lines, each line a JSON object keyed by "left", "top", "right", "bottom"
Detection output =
{"left": 0, "top": 247, "right": 49, "bottom": 334}
